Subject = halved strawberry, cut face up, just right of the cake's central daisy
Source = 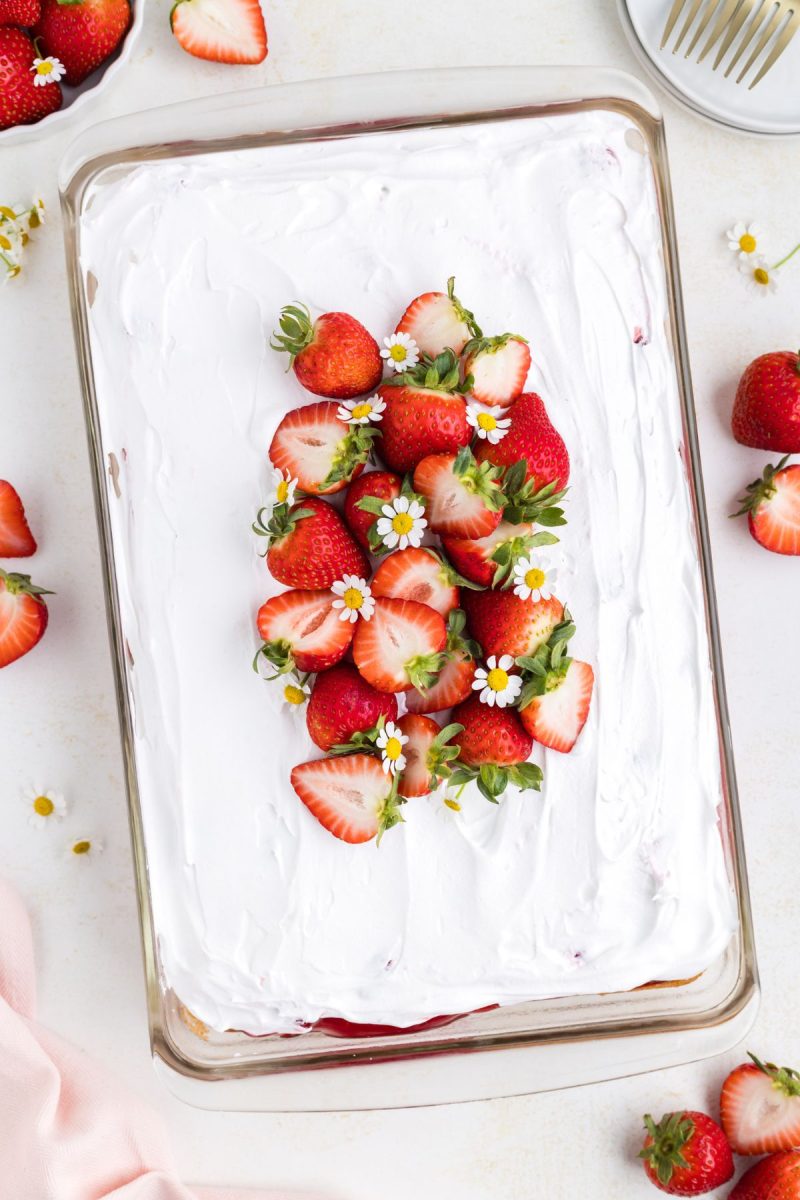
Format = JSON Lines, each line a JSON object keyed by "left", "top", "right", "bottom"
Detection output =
{"left": 414, "top": 446, "right": 505, "bottom": 538}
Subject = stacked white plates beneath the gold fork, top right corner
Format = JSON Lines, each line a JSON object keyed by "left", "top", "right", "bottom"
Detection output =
{"left": 618, "top": 0, "right": 800, "bottom": 137}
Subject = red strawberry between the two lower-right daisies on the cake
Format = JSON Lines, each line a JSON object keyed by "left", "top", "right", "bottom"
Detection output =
{"left": 462, "top": 592, "right": 564, "bottom": 659}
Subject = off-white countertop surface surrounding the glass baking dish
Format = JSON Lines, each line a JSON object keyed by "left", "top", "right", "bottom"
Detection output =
{"left": 0, "top": 0, "right": 800, "bottom": 1200}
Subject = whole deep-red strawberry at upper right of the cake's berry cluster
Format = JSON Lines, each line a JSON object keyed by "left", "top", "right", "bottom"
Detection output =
{"left": 475, "top": 391, "right": 570, "bottom": 491}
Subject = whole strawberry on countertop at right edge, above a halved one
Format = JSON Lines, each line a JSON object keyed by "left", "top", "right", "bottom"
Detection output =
{"left": 732, "top": 350, "right": 800, "bottom": 454}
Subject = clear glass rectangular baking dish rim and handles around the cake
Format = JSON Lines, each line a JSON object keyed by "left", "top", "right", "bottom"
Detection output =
{"left": 60, "top": 67, "right": 758, "bottom": 1111}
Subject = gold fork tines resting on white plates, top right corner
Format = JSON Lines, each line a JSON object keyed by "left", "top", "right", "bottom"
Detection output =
{"left": 661, "top": 0, "right": 800, "bottom": 89}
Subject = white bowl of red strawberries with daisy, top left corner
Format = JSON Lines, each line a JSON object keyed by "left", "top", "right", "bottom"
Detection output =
{"left": 0, "top": 0, "right": 144, "bottom": 145}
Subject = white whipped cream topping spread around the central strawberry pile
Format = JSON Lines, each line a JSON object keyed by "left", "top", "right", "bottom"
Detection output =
{"left": 82, "top": 112, "right": 736, "bottom": 1033}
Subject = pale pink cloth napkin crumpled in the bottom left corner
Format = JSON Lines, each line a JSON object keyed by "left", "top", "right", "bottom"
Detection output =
{"left": 0, "top": 881, "right": 326, "bottom": 1200}
